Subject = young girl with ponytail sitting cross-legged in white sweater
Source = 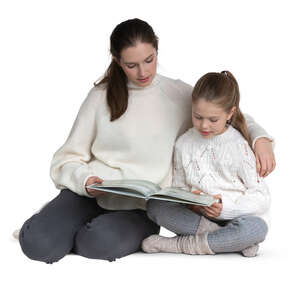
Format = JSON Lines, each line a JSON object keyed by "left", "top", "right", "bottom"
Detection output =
{"left": 142, "top": 71, "right": 270, "bottom": 256}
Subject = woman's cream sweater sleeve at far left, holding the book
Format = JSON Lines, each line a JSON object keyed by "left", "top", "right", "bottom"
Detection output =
{"left": 50, "top": 89, "right": 99, "bottom": 197}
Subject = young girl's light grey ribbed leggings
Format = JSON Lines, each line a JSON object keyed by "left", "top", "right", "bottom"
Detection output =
{"left": 147, "top": 200, "right": 268, "bottom": 253}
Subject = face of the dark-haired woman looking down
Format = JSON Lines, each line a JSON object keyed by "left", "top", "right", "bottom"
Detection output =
{"left": 119, "top": 42, "right": 157, "bottom": 87}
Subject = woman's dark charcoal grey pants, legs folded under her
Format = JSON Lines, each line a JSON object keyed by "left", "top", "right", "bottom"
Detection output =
{"left": 19, "top": 190, "right": 159, "bottom": 263}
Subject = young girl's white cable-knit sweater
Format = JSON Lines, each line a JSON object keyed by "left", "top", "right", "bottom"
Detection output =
{"left": 172, "top": 126, "right": 270, "bottom": 225}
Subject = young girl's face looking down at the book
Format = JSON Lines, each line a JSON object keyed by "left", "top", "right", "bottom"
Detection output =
{"left": 192, "top": 98, "right": 235, "bottom": 138}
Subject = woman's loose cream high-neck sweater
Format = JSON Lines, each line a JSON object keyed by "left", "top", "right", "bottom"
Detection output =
{"left": 50, "top": 74, "right": 268, "bottom": 210}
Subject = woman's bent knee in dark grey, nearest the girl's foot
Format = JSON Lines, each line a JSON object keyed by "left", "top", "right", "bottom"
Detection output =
{"left": 74, "top": 211, "right": 159, "bottom": 261}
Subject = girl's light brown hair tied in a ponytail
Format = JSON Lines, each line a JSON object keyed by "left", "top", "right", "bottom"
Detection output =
{"left": 192, "top": 71, "right": 252, "bottom": 148}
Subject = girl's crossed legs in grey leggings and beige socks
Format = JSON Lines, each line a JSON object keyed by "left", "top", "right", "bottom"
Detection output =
{"left": 143, "top": 200, "right": 268, "bottom": 256}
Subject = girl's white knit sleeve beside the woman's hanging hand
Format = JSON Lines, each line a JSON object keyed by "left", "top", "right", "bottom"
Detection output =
{"left": 218, "top": 142, "right": 270, "bottom": 220}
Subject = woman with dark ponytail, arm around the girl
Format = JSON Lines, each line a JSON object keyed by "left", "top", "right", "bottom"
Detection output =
{"left": 19, "top": 19, "right": 275, "bottom": 263}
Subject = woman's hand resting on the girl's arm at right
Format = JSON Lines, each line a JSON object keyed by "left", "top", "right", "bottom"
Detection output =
{"left": 254, "top": 138, "right": 276, "bottom": 177}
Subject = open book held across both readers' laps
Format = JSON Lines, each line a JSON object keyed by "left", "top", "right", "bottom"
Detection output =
{"left": 87, "top": 179, "right": 218, "bottom": 206}
